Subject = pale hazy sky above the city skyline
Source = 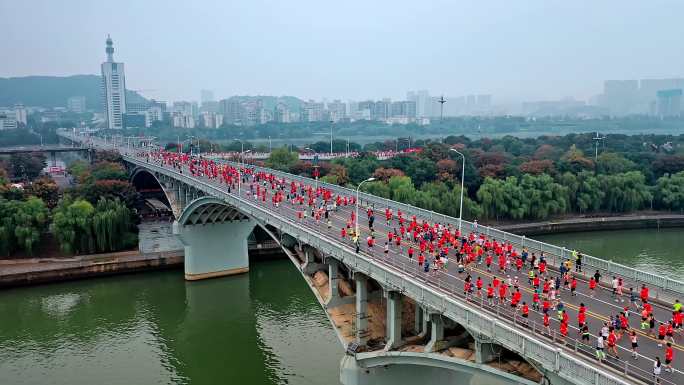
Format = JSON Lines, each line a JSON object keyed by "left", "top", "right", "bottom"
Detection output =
{"left": 0, "top": 0, "right": 684, "bottom": 102}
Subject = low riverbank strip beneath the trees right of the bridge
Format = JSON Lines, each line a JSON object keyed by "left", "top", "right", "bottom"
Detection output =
{"left": 493, "top": 214, "right": 684, "bottom": 235}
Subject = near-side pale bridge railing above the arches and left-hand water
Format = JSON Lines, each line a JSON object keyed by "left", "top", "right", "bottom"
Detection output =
{"left": 126, "top": 157, "right": 628, "bottom": 385}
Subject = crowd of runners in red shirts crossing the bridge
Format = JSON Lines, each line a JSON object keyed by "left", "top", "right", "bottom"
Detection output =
{"left": 138, "top": 151, "right": 684, "bottom": 377}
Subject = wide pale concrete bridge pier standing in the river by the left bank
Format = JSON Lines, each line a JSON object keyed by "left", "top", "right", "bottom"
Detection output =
{"left": 173, "top": 219, "right": 254, "bottom": 281}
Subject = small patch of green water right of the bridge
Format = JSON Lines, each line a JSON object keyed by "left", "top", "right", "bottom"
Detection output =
{"left": 532, "top": 228, "right": 684, "bottom": 280}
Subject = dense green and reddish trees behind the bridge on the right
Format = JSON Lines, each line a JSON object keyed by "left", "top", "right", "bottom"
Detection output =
{"left": 265, "top": 134, "right": 684, "bottom": 220}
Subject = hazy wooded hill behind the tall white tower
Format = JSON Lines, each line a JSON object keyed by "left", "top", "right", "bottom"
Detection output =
{"left": 0, "top": 75, "right": 144, "bottom": 111}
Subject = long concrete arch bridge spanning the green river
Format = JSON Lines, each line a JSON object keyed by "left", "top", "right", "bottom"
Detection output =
{"left": 60, "top": 133, "right": 684, "bottom": 385}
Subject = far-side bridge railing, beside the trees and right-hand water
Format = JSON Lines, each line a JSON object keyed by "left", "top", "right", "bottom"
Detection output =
{"left": 220, "top": 162, "right": 684, "bottom": 302}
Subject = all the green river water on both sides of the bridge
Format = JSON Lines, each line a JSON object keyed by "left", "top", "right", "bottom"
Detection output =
{"left": 0, "top": 229, "right": 684, "bottom": 385}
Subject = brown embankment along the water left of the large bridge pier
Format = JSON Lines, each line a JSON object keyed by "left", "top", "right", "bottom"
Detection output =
{"left": 0, "top": 250, "right": 184, "bottom": 287}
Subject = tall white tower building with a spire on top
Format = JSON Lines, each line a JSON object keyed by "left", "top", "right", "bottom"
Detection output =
{"left": 102, "top": 35, "right": 126, "bottom": 129}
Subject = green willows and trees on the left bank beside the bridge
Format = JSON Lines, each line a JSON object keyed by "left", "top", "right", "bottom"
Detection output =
{"left": 0, "top": 153, "right": 138, "bottom": 256}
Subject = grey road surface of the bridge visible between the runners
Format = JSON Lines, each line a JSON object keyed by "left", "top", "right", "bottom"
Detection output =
{"left": 61, "top": 131, "right": 684, "bottom": 384}
